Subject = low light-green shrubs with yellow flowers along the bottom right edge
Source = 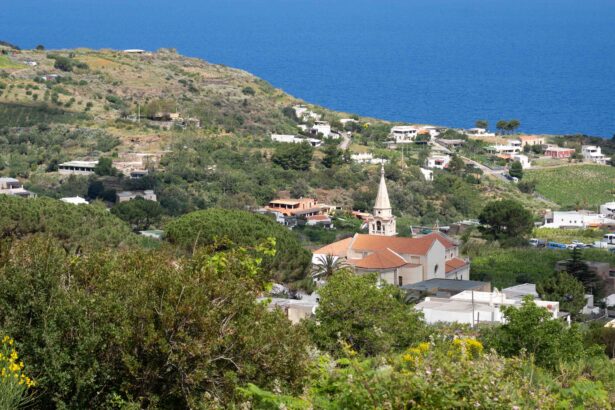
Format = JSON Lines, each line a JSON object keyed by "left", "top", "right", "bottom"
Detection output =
{"left": 240, "top": 337, "right": 615, "bottom": 410}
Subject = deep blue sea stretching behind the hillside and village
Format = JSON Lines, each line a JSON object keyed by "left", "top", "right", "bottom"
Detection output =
{"left": 0, "top": 0, "right": 615, "bottom": 138}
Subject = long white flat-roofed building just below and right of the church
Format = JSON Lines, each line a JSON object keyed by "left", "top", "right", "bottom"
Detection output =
{"left": 415, "top": 289, "right": 559, "bottom": 326}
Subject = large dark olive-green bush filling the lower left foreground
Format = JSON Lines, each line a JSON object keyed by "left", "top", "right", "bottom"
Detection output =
{"left": 0, "top": 237, "right": 307, "bottom": 409}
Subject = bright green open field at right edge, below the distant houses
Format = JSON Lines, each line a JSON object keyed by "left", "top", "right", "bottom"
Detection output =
{"left": 525, "top": 165, "right": 615, "bottom": 209}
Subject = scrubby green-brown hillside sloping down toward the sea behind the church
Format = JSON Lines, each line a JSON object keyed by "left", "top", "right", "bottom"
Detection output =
{"left": 0, "top": 48, "right": 543, "bottom": 231}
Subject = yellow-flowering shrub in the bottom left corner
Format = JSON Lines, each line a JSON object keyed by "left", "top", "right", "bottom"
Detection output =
{"left": 0, "top": 336, "right": 36, "bottom": 410}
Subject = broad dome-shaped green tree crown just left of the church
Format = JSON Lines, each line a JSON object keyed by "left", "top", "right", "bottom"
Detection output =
{"left": 165, "top": 208, "right": 311, "bottom": 282}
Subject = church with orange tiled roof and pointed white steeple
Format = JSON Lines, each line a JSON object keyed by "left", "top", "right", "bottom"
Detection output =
{"left": 314, "top": 167, "right": 470, "bottom": 286}
